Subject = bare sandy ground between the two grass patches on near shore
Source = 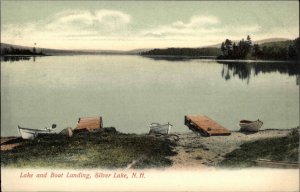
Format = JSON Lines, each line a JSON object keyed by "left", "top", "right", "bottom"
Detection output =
{"left": 171, "top": 129, "right": 291, "bottom": 169}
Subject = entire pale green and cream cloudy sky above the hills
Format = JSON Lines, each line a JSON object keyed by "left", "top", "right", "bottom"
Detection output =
{"left": 1, "top": 0, "right": 299, "bottom": 50}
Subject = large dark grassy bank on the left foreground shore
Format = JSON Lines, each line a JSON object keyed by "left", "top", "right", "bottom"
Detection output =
{"left": 1, "top": 131, "right": 176, "bottom": 169}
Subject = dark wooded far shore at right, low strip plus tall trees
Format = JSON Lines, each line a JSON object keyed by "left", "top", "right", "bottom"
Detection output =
{"left": 141, "top": 35, "right": 300, "bottom": 61}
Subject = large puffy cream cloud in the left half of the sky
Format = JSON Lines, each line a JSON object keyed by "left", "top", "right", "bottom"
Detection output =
{"left": 1, "top": 9, "right": 131, "bottom": 42}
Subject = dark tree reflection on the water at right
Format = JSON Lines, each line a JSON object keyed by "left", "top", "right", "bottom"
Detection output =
{"left": 218, "top": 61, "right": 299, "bottom": 83}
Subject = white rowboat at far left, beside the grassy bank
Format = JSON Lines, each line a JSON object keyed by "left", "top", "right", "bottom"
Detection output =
{"left": 18, "top": 124, "right": 56, "bottom": 139}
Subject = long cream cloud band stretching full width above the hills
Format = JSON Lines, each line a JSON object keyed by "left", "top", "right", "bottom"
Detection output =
{"left": 1, "top": 9, "right": 299, "bottom": 50}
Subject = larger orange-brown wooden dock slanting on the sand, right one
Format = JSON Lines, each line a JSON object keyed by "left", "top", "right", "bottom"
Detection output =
{"left": 184, "top": 115, "right": 231, "bottom": 137}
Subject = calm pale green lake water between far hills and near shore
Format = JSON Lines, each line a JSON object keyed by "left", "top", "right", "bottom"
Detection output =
{"left": 1, "top": 56, "right": 299, "bottom": 136}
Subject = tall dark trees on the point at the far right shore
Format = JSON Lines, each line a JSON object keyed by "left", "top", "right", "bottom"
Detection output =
{"left": 218, "top": 35, "right": 300, "bottom": 60}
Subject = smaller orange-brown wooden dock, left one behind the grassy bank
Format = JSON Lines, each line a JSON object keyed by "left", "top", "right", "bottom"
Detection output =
{"left": 74, "top": 117, "right": 103, "bottom": 132}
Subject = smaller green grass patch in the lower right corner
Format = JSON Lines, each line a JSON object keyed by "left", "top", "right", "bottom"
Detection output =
{"left": 218, "top": 129, "right": 299, "bottom": 168}
